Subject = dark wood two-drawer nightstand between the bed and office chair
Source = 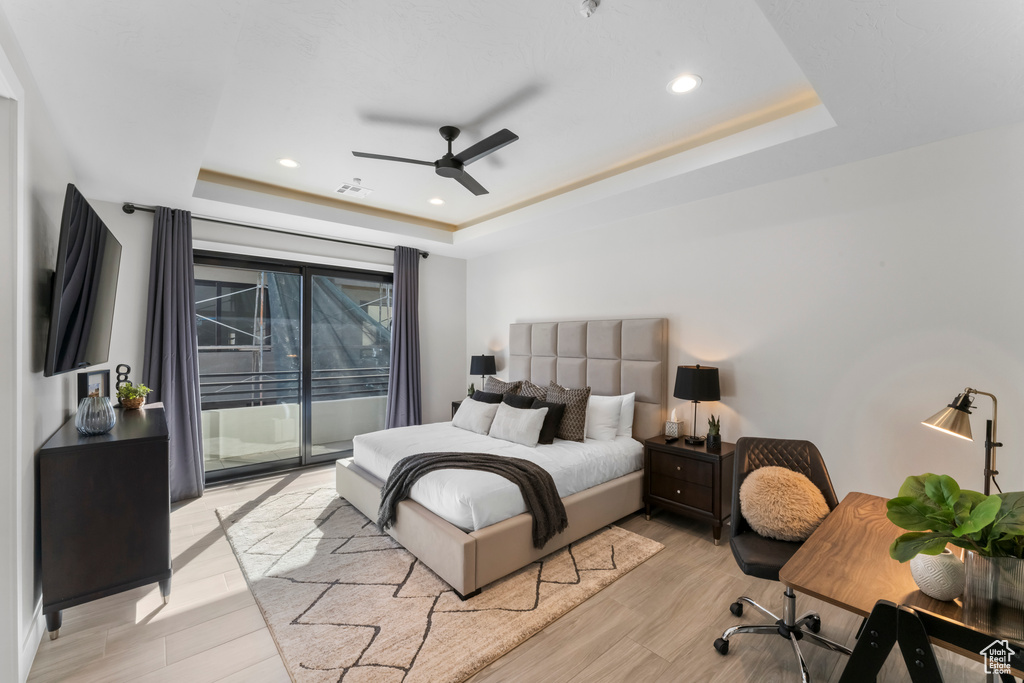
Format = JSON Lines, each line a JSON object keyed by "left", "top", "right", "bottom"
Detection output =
{"left": 643, "top": 435, "right": 736, "bottom": 546}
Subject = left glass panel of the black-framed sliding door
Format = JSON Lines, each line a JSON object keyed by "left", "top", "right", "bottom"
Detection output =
{"left": 195, "top": 259, "right": 303, "bottom": 480}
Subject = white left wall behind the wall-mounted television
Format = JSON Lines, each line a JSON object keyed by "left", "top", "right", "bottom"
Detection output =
{"left": 0, "top": 11, "right": 74, "bottom": 681}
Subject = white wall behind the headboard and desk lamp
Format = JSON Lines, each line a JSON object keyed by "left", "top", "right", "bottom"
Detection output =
{"left": 467, "top": 120, "right": 1024, "bottom": 496}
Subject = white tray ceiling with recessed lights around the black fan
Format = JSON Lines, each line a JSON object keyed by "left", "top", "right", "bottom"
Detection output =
{"left": 0, "top": 0, "right": 1024, "bottom": 256}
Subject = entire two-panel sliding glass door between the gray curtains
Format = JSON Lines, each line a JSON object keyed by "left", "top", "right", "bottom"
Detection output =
{"left": 195, "top": 254, "right": 391, "bottom": 481}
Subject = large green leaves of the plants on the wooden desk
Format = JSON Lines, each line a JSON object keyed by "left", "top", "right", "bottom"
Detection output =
{"left": 886, "top": 473, "right": 1024, "bottom": 562}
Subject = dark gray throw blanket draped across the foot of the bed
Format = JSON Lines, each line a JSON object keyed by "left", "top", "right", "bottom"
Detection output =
{"left": 377, "top": 453, "right": 568, "bottom": 548}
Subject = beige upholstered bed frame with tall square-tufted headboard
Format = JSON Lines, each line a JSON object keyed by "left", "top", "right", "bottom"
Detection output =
{"left": 337, "top": 317, "right": 669, "bottom": 598}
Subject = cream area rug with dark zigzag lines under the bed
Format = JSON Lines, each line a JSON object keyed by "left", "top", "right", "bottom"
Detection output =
{"left": 217, "top": 488, "right": 664, "bottom": 683}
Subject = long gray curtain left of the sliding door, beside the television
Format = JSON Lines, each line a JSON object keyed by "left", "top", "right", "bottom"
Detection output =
{"left": 142, "top": 207, "right": 204, "bottom": 501}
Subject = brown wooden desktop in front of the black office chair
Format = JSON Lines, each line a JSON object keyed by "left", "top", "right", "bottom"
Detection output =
{"left": 779, "top": 493, "right": 1021, "bottom": 676}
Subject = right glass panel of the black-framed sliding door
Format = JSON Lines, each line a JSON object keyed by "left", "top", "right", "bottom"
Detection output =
{"left": 309, "top": 271, "right": 392, "bottom": 460}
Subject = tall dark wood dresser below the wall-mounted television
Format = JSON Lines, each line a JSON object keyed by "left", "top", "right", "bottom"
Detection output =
{"left": 38, "top": 407, "right": 171, "bottom": 639}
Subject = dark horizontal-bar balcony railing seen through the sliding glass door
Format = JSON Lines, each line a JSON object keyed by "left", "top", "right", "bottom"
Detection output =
{"left": 199, "top": 366, "right": 390, "bottom": 411}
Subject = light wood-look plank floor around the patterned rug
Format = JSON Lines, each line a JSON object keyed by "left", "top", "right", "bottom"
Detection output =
{"left": 29, "top": 465, "right": 984, "bottom": 683}
